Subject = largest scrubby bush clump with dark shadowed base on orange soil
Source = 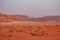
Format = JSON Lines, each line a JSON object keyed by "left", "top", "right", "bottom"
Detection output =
{"left": 28, "top": 26, "right": 45, "bottom": 36}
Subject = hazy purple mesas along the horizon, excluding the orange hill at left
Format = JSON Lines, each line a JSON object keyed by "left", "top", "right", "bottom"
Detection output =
{"left": 11, "top": 15, "right": 60, "bottom": 22}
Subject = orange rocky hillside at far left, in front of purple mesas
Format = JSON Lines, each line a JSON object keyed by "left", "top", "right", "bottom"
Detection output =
{"left": 0, "top": 13, "right": 20, "bottom": 22}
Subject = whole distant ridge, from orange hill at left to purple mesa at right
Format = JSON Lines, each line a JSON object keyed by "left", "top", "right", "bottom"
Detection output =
{"left": 0, "top": 13, "right": 60, "bottom": 22}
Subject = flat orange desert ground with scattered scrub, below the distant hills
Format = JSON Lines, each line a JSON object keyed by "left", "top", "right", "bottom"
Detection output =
{"left": 0, "top": 22, "right": 60, "bottom": 40}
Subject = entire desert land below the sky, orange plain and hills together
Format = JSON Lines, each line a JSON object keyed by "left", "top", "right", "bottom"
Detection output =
{"left": 0, "top": 14, "right": 60, "bottom": 40}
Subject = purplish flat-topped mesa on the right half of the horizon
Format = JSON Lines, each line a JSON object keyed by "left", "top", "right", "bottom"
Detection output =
{"left": 31, "top": 16, "right": 60, "bottom": 22}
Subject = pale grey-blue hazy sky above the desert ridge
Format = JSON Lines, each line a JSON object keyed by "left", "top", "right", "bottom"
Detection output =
{"left": 0, "top": 0, "right": 60, "bottom": 17}
